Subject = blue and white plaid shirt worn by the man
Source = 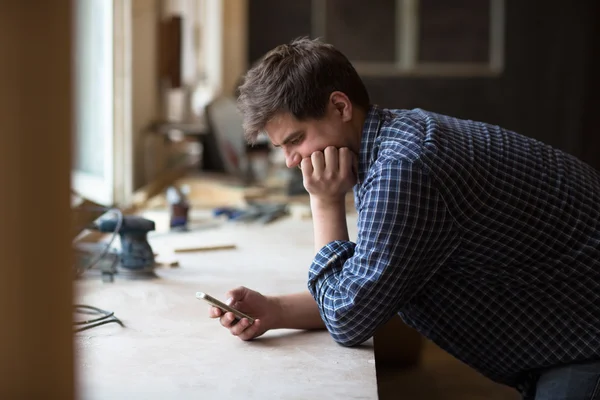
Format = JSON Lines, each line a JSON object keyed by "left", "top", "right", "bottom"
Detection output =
{"left": 308, "top": 106, "right": 600, "bottom": 393}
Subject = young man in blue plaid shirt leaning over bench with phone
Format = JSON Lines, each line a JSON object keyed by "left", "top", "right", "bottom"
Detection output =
{"left": 209, "top": 39, "right": 600, "bottom": 399}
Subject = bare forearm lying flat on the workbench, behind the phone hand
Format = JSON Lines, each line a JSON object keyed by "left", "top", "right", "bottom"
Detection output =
{"left": 274, "top": 291, "right": 325, "bottom": 329}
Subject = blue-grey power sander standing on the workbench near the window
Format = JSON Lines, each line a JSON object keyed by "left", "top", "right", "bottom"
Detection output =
{"left": 94, "top": 215, "right": 157, "bottom": 281}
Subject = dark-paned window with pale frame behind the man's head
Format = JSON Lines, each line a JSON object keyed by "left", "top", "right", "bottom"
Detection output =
{"left": 312, "top": 0, "right": 504, "bottom": 76}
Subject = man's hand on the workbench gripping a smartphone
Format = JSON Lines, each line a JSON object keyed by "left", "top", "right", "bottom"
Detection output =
{"left": 208, "top": 286, "right": 281, "bottom": 340}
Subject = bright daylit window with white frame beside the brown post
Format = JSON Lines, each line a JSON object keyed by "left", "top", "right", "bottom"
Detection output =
{"left": 71, "top": 0, "right": 132, "bottom": 206}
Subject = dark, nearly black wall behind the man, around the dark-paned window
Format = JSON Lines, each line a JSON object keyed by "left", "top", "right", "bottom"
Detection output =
{"left": 248, "top": 0, "right": 600, "bottom": 168}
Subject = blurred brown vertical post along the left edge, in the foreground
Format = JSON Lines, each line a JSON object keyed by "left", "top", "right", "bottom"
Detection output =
{"left": 0, "top": 0, "right": 75, "bottom": 400}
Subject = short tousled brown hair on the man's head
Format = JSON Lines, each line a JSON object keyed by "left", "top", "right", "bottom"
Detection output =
{"left": 238, "top": 38, "right": 370, "bottom": 142}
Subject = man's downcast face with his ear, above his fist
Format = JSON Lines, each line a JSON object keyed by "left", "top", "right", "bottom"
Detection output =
{"left": 265, "top": 96, "right": 351, "bottom": 168}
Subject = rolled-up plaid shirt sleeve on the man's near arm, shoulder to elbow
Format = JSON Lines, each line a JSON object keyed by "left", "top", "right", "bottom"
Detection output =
{"left": 308, "top": 157, "right": 459, "bottom": 346}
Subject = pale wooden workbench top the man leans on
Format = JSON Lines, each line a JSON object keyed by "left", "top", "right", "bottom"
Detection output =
{"left": 75, "top": 212, "right": 377, "bottom": 399}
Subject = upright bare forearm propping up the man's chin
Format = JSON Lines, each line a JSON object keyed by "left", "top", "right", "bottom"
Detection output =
{"left": 310, "top": 196, "right": 349, "bottom": 253}
